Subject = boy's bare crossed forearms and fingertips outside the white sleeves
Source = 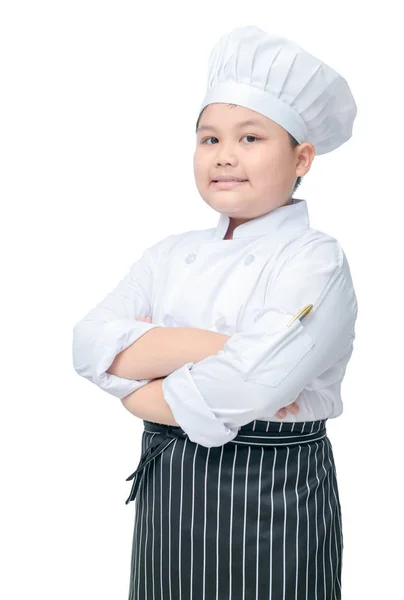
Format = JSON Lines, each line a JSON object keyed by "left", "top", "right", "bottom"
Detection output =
{"left": 107, "top": 319, "right": 297, "bottom": 426}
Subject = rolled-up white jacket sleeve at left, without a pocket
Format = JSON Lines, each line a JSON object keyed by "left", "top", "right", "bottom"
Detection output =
{"left": 73, "top": 238, "right": 167, "bottom": 399}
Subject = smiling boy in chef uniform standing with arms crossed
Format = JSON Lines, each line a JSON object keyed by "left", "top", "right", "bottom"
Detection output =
{"left": 73, "top": 26, "right": 358, "bottom": 600}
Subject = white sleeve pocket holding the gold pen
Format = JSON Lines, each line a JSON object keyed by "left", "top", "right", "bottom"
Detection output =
{"left": 242, "top": 315, "right": 315, "bottom": 387}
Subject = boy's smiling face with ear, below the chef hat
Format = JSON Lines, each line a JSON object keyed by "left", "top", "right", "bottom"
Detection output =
{"left": 194, "top": 103, "right": 315, "bottom": 226}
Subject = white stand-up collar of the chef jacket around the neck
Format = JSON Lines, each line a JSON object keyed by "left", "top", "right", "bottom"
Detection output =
{"left": 213, "top": 198, "right": 310, "bottom": 241}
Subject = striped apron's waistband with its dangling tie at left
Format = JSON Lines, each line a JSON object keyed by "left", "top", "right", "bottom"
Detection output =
{"left": 125, "top": 419, "right": 327, "bottom": 504}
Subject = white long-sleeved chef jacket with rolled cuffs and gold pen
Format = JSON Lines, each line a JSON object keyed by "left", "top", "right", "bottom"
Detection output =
{"left": 73, "top": 198, "right": 358, "bottom": 447}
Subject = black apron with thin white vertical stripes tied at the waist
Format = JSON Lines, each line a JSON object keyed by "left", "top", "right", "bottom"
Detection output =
{"left": 126, "top": 419, "right": 343, "bottom": 600}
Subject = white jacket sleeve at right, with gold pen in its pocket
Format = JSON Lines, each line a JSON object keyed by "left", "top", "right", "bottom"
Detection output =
{"left": 163, "top": 236, "right": 357, "bottom": 447}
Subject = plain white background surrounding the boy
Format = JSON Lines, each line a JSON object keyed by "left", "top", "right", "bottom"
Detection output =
{"left": 0, "top": 0, "right": 404, "bottom": 600}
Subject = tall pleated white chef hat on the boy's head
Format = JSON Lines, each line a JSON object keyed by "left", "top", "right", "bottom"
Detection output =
{"left": 199, "top": 25, "right": 357, "bottom": 155}
